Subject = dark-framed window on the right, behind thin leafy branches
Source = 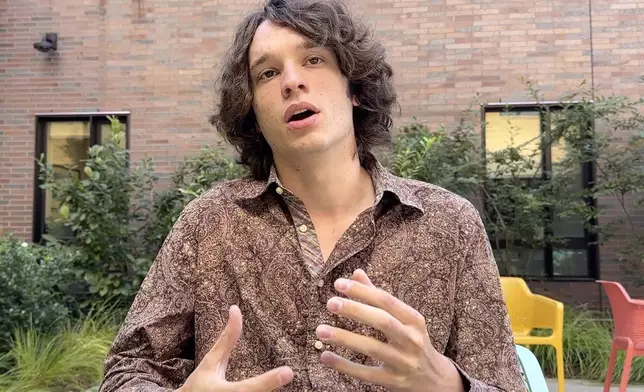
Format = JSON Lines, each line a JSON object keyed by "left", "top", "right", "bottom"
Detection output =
{"left": 481, "top": 102, "right": 599, "bottom": 280}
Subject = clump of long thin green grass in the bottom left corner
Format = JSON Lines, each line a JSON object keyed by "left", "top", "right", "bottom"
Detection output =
{"left": 0, "top": 308, "right": 118, "bottom": 392}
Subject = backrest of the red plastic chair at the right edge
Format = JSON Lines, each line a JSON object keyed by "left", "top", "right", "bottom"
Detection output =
{"left": 597, "top": 280, "right": 644, "bottom": 341}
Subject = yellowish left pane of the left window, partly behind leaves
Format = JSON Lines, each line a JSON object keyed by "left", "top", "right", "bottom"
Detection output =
{"left": 45, "top": 121, "right": 89, "bottom": 238}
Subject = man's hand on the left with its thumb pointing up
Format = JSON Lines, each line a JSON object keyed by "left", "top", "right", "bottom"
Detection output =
{"left": 178, "top": 305, "right": 293, "bottom": 392}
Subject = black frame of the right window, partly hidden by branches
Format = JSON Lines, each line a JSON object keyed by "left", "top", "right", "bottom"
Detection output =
{"left": 481, "top": 101, "right": 600, "bottom": 282}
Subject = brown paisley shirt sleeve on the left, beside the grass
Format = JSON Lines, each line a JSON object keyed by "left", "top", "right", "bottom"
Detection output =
{"left": 99, "top": 207, "right": 197, "bottom": 392}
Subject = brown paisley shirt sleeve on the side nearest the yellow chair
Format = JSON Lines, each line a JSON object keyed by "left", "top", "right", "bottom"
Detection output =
{"left": 446, "top": 202, "right": 526, "bottom": 392}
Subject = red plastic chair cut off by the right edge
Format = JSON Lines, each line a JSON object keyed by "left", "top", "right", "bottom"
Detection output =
{"left": 597, "top": 280, "right": 644, "bottom": 392}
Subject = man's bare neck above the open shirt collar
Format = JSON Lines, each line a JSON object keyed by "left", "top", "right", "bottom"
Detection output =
{"left": 275, "top": 146, "right": 375, "bottom": 216}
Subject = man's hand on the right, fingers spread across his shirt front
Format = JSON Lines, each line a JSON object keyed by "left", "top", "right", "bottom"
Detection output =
{"left": 316, "top": 270, "right": 464, "bottom": 392}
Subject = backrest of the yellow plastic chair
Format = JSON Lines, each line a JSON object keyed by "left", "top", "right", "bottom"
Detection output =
{"left": 501, "top": 276, "right": 534, "bottom": 334}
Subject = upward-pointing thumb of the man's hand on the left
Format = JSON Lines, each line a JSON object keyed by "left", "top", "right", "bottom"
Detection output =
{"left": 203, "top": 305, "right": 242, "bottom": 379}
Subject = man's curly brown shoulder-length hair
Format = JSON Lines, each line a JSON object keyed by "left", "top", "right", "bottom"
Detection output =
{"left": 210, "top": 0, "right": 396, "bottom": 180}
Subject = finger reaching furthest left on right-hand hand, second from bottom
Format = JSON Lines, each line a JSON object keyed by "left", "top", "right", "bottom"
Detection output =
{"left": 315, "top": 325, "right": 406, "bottom": 369}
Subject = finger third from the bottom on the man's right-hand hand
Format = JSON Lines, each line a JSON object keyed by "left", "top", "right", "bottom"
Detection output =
{"left": 327, "top": 297, "right": 422, "bottom": 344}
